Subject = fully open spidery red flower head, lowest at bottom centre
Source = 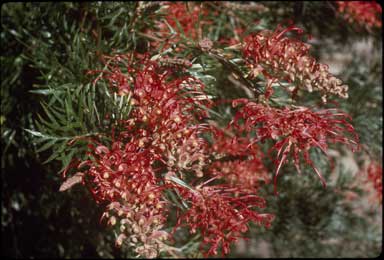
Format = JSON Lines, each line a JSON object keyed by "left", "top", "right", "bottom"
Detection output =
{"left": 177, "top": 182, "right": 274, "bottom": 256}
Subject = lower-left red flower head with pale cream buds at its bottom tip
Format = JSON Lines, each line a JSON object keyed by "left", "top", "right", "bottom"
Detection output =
{"left": 79, "top": 140, "right": 168, "bottom": 258}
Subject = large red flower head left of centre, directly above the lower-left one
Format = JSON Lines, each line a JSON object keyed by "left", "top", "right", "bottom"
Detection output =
{"left": 104, "top": 56, "right": 210, "bottom": 177}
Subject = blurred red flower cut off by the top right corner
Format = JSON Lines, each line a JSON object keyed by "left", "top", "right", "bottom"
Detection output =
{"left": 336, "top": 1, "right": 382, "bottom": 28}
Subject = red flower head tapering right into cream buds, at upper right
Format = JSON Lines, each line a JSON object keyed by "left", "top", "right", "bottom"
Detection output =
{"left": 243, "top": 26, "right": 348, "bottom": 102}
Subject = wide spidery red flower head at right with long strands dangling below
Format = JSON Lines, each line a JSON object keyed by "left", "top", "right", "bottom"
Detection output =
{"left": 231, "top": 100, "right": 358, "bottom": 191}
